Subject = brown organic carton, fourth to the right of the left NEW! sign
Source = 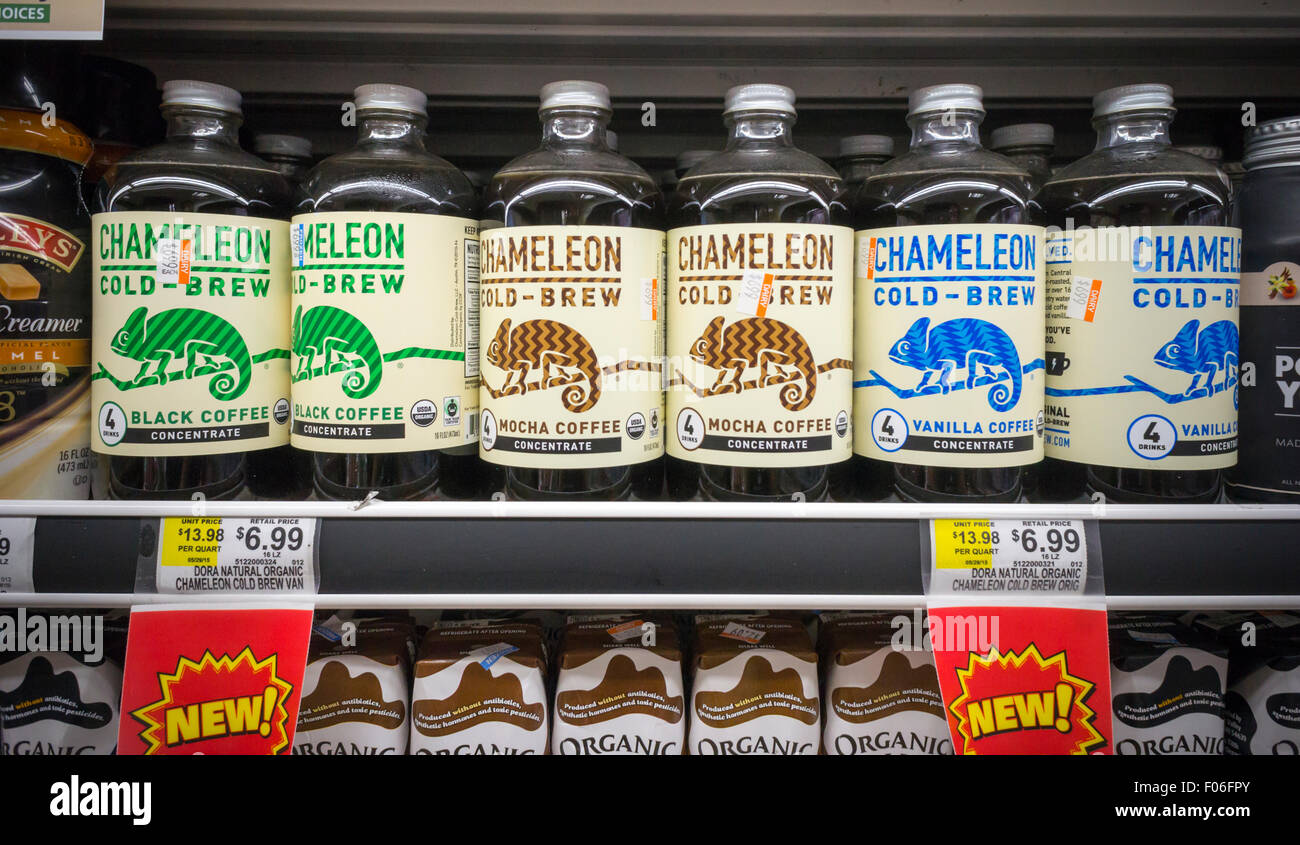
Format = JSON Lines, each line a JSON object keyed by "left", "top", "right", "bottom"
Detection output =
{"left": 690, "top": 615, "right": 822, "bottom": 754}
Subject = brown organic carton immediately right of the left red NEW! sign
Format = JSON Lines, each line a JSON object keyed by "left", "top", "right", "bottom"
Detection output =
{"left": 294, "top": 619, "right": 415, "bottom": 755}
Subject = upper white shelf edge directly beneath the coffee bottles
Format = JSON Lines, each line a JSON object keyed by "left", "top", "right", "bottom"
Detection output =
{"left": 0, "top": 499, "right": 1300, "bottom": 521}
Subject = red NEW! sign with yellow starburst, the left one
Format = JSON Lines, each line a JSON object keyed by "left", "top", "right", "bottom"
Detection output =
{"left": 117, "top": 606, "right": 312, "bottom": 754}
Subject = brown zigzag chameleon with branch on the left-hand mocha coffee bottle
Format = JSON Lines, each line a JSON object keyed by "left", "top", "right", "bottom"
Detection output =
{"left": 482, "top": 317, "right": 660, "bottom": 413}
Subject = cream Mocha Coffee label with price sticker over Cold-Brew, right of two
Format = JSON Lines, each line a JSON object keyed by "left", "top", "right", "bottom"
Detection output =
{"left": 666, "top": 224, "right": 853, "bottom": 467}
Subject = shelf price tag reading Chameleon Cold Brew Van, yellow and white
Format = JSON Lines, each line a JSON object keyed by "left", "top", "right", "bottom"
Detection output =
{"left": 156, "top": 516, "right": 316, "bottom": 595}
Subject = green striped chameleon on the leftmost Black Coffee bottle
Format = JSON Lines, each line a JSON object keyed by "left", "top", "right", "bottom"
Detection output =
{"left": 96, "top": 306, "right": 252, "bottom": 402}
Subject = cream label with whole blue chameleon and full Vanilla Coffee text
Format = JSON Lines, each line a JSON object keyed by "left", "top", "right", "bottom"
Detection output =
{"left": 853, "top": 224, "right": 1044, "bottom": 467}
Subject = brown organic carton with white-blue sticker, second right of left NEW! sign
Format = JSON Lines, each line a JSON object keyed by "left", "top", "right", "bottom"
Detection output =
{"left": 411, "top": 620, "right": 547, "bottom": 754}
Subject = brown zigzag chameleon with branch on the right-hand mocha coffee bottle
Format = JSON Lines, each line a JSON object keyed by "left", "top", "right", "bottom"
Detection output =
{"left": 677, "top": 317, "right": 853, "bottom": 411}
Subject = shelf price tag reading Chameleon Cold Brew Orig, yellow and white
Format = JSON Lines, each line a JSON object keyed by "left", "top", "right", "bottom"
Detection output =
{"left": 930, "top": 519, "right": 1088, "bottom": 597}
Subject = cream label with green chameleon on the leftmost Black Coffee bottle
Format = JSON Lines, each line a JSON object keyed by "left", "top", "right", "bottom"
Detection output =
{"left": 91, "top": 212, "right": 290, "bottom": 456}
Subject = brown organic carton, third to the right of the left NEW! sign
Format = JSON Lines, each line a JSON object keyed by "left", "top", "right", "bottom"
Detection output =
{"left": 551, "top": 615, "right": 686, "bottom": 755}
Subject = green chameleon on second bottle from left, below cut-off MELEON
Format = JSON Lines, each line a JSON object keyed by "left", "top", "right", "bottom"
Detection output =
{"left": 294, "top": 306, "right": 385, "bottom": 399}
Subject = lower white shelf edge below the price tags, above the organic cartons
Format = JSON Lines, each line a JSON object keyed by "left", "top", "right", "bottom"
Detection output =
{"left": 0, "top": 593, "right": 1300, "bottom": 611}
